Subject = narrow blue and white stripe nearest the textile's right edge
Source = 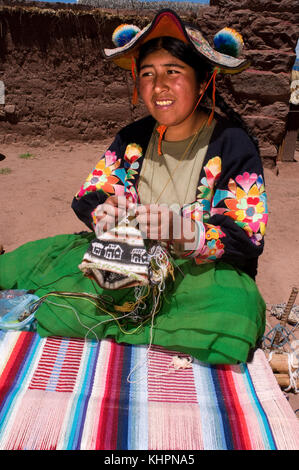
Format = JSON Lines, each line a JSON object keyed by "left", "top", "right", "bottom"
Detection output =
{"left": 240, "top": 364, "right": 277, "bottom": 450}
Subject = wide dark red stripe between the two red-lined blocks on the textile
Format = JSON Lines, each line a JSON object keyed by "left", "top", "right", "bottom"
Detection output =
{"left": 96, "top": 342, "right": 124, "bottom": 450}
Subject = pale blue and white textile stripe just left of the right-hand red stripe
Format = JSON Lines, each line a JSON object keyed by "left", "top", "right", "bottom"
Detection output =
{"left": 193, "top": 359, "right": 227, "bottom": 450}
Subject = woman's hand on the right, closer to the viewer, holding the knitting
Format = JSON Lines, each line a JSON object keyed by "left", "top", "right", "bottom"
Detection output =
{"left": 136, "top": 204, "right": 197, "bottom": 252}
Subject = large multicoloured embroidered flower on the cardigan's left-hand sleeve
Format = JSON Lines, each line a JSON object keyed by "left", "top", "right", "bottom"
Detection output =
{"left": 77, "top": 150, "right": 120, "bottom": 198}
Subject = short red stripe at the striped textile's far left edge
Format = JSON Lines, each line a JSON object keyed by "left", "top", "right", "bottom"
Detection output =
{"left": 0, "top": 331, "right": 33, "bottom": 405}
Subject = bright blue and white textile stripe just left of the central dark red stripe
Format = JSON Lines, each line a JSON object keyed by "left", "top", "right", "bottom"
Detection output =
{"left": 63, "top": 340, "right": 100, "bottom": 450}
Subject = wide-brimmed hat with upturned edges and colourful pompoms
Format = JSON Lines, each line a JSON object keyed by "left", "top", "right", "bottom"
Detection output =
{"left": 103, "top": 9, "right": 250, "bottom": 74}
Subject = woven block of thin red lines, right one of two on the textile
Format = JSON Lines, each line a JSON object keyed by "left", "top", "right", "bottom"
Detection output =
{"left": 148, "top": 346, "right": 197, "bottom": 403}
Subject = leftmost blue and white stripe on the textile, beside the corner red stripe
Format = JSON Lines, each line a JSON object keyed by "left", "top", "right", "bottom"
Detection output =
{"left": 0, "top": 333, "right": 43, "bottom": 438}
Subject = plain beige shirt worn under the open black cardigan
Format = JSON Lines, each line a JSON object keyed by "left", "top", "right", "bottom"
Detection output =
{"left": 138, "top": 120, "right": 216, "bottom": 207}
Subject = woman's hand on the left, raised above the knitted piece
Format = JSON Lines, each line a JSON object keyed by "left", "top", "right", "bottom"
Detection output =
{"left": 94, "top": 196, "right": 131, "bottom": 237}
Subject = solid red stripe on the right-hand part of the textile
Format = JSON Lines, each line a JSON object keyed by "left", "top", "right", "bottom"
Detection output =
{"left": 217, "top": 365, "right": 252, "bottom": 450}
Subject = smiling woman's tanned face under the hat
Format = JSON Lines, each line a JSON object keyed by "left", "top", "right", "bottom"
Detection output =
{"left": 139, "top": 49, "right": 201, "bottom": 137}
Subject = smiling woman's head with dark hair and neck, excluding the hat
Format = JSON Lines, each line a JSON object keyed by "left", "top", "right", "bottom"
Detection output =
{"left": 136, "top": 36, "right": 210, "bottom": 141}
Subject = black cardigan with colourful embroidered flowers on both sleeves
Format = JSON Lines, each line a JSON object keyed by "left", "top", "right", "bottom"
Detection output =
{"left": 72, "top": 116, "right": 267, "bottom": 278}
